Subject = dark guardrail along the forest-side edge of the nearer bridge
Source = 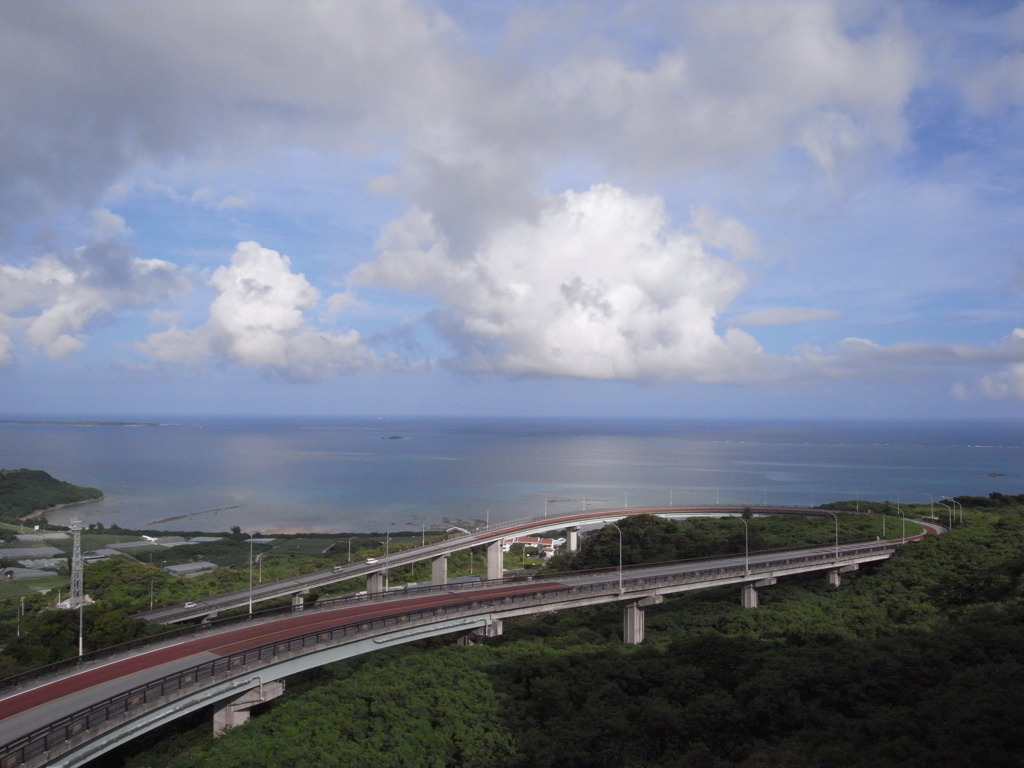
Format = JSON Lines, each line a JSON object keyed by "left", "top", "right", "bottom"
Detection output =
{"left": 0, "top": 543, "right": 896, "bottom": 768}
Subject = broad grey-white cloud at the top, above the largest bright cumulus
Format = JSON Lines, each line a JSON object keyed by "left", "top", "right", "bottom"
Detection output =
{"left": 375, "top": 0, "right": 923, "bottom": 272}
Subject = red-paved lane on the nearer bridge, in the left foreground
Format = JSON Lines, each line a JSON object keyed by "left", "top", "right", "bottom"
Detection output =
{"left": 0, "top": 583, "right": 562, "bottom": 725}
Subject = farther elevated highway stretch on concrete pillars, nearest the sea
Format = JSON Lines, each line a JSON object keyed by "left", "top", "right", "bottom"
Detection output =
{"left": 139, "top": 506, "right": 847, "bottom": 624}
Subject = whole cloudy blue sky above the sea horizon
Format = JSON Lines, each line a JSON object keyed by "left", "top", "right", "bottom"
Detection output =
{"left": 0, "top": 0, "right": 1024, "bottom": 419}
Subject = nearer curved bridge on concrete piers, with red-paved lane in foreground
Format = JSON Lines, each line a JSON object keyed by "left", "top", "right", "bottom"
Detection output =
{"left": 0, "top": 536, "right": 898, "bottom": 768}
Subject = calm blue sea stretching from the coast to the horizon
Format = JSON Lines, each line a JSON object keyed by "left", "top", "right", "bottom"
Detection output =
{"left": 0, "top": 418, "right": 1024, "bottom": 531}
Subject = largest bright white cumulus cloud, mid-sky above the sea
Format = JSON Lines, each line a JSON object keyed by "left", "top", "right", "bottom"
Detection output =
{"left": 351, "top": 184, "right": 760, "bottom": 381}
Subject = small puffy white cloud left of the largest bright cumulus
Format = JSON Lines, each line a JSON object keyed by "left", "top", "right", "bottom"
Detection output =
{"left": 140, "top": 243, "right": 376, "bottom": 380}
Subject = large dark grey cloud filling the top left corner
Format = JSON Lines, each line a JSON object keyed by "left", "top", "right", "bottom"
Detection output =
{"left": 0, "top": 0, "right": 463, "bottom": 236}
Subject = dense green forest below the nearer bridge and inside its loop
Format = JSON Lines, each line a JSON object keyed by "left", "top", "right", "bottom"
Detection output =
{"left": 103, "top": 496, "right": 1024, "bottom": 768}
